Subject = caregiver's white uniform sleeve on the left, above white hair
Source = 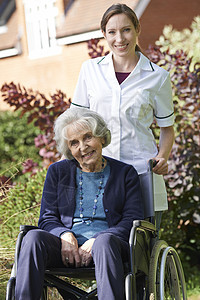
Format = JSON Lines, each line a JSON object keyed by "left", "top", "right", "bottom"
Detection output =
{"left": 72, "top": 63, "right": 90, "bottom": 108}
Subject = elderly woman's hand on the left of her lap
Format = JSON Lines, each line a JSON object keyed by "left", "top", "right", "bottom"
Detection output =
{"left": 61, "top": 232, "right": 81, "bottom": 268}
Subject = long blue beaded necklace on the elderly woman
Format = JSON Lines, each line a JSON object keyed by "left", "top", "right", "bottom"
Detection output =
{"left": 79, "top": 158, "right": 105, "bottom": 225}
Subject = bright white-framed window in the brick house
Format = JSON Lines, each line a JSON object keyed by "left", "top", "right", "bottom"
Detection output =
{"left": 24, "top": 0, "right": 61, "bottom": 58}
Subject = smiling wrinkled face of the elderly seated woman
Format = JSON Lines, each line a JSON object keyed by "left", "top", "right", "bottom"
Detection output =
{"left": 66, "top": 126, "right": 104, "bottom": 172}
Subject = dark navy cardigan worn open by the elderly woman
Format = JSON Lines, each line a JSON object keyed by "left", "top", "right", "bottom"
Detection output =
{"left": 38, "top": 157, "right": 143, "bottom": 242}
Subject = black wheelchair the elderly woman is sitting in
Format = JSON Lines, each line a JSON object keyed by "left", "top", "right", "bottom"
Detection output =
{"left": 6, "top": 160, "right": 187, "bottom": 300}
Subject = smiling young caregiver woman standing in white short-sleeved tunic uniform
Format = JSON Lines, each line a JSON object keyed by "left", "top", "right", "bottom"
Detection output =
{"left": 71, "top": 4, "right": 174, "bottom": 227}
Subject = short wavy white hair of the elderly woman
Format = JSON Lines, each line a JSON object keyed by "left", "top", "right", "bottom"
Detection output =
{"left": 54, "top": 108, "right": 111, "bottom": 159}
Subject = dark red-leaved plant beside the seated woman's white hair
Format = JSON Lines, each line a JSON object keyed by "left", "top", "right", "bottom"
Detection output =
{"left": 1, "top": 82, "right": 71, "bottom": 168}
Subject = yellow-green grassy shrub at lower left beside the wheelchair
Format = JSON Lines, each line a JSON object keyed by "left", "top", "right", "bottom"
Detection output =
{"left": 0, "top": 166, "right": 47, "bottom": 300}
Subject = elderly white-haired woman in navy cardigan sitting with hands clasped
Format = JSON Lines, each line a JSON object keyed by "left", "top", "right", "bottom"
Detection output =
{"left": 16, "top": 109, "right": 143, "bottom": 300}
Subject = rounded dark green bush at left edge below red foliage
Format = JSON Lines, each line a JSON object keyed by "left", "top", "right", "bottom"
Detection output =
{"left": 0, "top": 111, "right": 41, "bottom": 177}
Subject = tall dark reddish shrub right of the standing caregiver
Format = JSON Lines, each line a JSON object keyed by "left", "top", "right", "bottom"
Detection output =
{"left": 145, "top": 47, "right": 200, "bottom": 266}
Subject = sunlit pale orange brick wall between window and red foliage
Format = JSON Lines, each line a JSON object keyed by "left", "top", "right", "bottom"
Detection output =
{"left": 0, "top": 40, "right": 109, "bottom": 110}
